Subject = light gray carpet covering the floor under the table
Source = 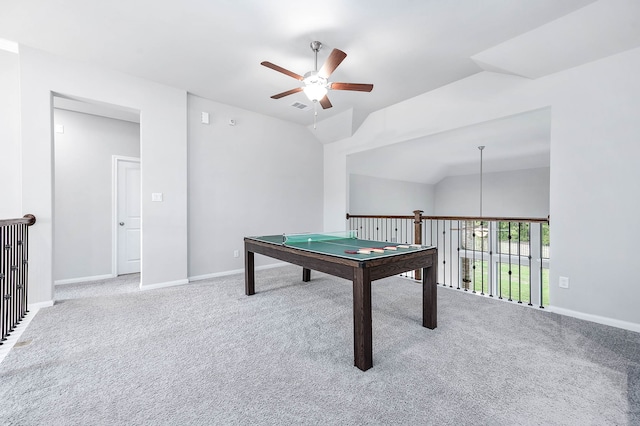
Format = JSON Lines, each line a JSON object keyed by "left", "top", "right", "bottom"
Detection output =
{"left": 0, "top": 267, "right": 640, "bottom": 425}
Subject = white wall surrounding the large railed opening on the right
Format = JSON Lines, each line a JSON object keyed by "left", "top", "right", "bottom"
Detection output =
{"left": 324, "top": 49, "right": 640, "bottom": 331}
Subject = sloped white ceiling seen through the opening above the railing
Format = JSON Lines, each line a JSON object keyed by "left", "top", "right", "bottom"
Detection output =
{"left": 347, "top": 108, "right": 551, "bottom": 184}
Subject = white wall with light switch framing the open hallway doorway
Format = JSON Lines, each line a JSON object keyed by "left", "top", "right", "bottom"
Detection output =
{"left": 20, "top": 46, "right": 188, "bottom": 303}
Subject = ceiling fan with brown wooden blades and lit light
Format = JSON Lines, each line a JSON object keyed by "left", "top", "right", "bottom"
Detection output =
{"left": 260, "top": 41, "right": 373, "bottom": 109}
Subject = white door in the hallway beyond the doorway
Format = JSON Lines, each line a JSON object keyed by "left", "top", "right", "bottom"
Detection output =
{"left": 116, "top": 159, "right": 141, "bottom": 275}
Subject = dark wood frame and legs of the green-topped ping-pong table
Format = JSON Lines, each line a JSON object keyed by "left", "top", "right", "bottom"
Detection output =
{"left": 244, "top": 238, "right": 438, "bottom": 371}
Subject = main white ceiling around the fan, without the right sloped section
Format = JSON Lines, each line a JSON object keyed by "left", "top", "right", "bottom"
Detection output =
{"left": 0, "top": 0, "right": 608, "bottom": 125}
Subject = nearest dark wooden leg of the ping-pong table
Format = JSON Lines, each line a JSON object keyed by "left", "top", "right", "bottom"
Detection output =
{"left": 353, "top": 268, "right": 373, "bottom": 371}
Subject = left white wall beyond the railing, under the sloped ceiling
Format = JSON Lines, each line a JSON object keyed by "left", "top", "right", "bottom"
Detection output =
{"left": 349, "top": 174, "right": 435, "bottom": 216}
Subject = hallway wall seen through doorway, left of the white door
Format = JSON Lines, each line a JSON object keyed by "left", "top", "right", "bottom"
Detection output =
{"left": 53, "top": 109, "right": 140, "bottom": 281}
